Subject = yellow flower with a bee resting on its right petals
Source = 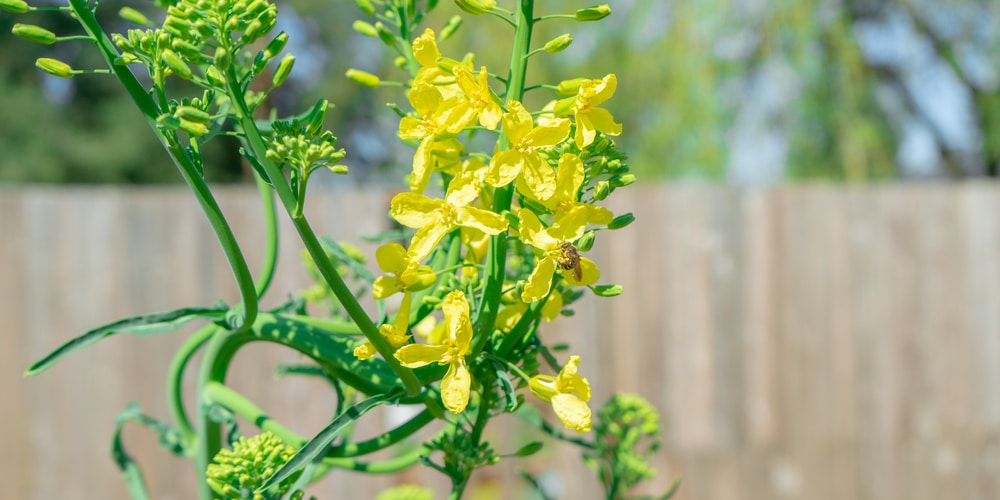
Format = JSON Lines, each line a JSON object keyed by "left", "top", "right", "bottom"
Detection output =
{"left": 518, "top": 208, "right": 601, "bottom": 302}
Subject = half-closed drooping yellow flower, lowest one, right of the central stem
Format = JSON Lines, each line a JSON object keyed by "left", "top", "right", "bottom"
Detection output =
{"left": 528, "top": 356, "right": 591, "bottom": 434}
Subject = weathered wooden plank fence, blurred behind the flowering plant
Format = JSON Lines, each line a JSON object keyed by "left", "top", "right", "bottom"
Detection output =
{"left": 0, "top": 183, "right": 1000, "bottom": 500}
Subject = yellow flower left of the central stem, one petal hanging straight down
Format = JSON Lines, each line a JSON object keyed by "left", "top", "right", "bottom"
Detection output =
{"left": 394, "top": 290, "right": 472, "bottom": 413}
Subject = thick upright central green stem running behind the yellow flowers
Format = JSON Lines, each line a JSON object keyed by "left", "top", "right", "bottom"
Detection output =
{"left": 472, "top": 0, "right": 535, "bottom": 356}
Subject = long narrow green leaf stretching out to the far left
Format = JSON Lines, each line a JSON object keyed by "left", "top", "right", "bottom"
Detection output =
{"left": 24, "top": 307, "right": 227, "bottom": 377}
